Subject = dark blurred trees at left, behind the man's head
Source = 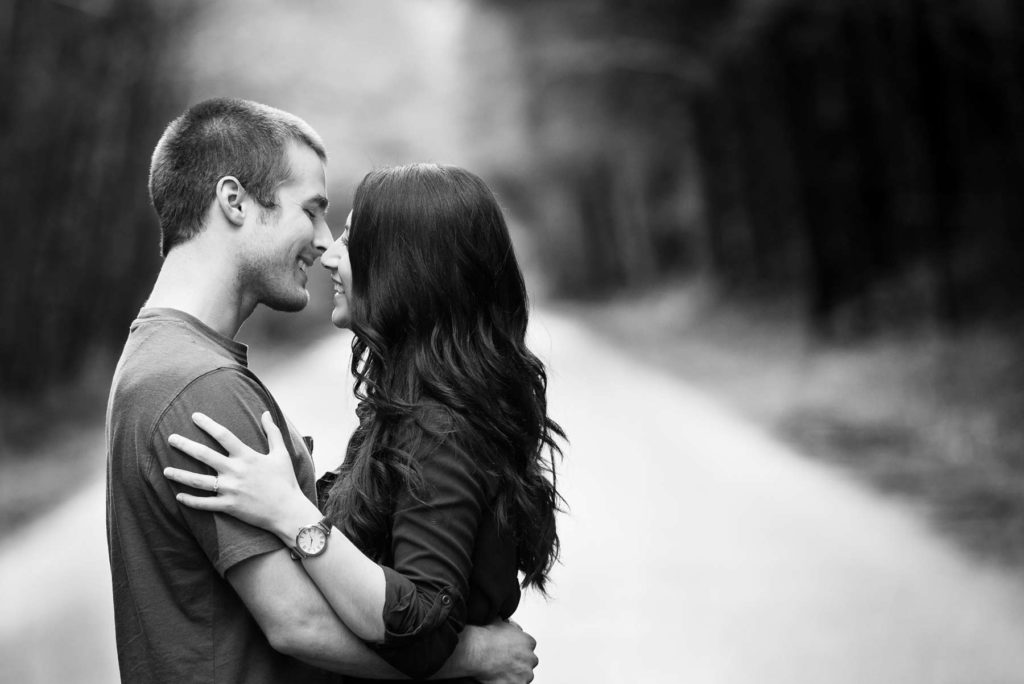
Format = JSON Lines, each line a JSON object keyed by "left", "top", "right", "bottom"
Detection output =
{"left": 0, "top": 0, "right": 186, "bottom": 395}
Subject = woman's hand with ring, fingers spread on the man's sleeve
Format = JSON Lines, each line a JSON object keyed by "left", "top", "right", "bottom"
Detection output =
{"left": 164, "top": 412, "right": 319, "bottom": 544}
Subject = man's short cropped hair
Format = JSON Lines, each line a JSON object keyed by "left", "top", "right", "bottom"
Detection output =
{"left": 150, "top": 97, "right": 327, "bottom": 256}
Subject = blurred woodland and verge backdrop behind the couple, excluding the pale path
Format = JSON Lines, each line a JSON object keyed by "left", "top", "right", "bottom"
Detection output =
{"left": 0, "top": 0, "right": 1024, "bottom": 557}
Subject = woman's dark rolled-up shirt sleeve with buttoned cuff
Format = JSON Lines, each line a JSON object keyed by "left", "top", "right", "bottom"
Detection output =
{"left": 376, "top": 432, "right": 487, "bottom": 678}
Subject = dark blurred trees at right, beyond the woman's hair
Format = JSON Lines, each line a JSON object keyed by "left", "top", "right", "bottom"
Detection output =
{"left": 484, "top": 0, "right": 1024, "bottom": 335}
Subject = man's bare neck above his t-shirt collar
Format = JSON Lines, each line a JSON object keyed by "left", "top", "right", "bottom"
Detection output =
{"left": 145, "top": 239, "right": 256, "bottom": 339}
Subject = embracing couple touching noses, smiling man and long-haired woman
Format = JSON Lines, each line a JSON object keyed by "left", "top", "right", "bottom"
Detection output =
{"left": 106, "top": 99, "right": 563, "bottom": 682}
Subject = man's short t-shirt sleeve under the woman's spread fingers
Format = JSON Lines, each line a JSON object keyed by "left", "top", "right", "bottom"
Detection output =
{"left": 145, "top": 369, "right": 284, "bottom": 576}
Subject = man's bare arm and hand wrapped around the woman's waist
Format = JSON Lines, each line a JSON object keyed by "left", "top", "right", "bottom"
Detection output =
{"left": 225, "top": 549, "right": 538, "bottom": 684}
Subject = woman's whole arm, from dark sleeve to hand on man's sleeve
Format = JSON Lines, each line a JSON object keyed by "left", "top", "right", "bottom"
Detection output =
{"left": 166, "top": 415, "right": 484, "bottom": 677}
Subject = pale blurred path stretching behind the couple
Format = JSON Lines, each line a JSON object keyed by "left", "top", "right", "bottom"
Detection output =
{"left": 0, "top": 314, "right": 1024, "bottom": 684}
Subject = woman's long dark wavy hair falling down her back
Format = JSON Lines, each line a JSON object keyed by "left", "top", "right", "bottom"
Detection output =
{"left": 327, "top": 164, "right": 565, "bottom": 592}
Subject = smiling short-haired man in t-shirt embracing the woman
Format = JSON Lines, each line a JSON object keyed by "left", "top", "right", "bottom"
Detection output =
{"left": 106, "top": 99, "right": 537, "bottom": 682}
